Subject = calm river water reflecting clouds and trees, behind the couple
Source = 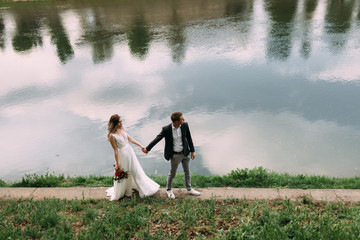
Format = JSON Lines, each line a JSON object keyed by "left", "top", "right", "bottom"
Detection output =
{"left": 0, "top": 0, "right": 360, "bottom": 181}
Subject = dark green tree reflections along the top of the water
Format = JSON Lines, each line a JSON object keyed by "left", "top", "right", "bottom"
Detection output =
{"left": 0, "top": 0, "right": 360, "bottom": 64}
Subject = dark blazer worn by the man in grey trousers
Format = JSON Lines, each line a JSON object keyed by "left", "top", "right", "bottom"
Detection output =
{"left": 146, "top": 122, "right": 195, "bottom": 161}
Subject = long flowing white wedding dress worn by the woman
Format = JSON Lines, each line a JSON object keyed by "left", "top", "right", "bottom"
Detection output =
{"left": 106, "top": 131, "right": 160, "bottom": 201}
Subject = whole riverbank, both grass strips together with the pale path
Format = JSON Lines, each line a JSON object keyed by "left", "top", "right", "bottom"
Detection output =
{"left": 0, "top": 168, "right": 360, "bottom": 239}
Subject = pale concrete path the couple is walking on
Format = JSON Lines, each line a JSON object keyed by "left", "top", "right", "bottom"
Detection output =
{"left": 0, "top": 187, "right": 360, "bottom": 202}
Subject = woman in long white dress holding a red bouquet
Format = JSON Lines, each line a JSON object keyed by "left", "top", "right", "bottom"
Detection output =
{"left": 106, "top": 114, "right": 159, "bottom": 201}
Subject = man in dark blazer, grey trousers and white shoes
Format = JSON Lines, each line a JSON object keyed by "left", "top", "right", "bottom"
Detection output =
{"left": 143, "top": 112, "right": 200, "bottom": 199}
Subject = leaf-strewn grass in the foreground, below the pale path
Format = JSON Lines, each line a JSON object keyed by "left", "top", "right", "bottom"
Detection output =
{"left": 0, "top": 197, "right": 360, "bottom": 239}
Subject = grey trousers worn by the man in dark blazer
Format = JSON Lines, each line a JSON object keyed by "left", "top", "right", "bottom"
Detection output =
{"left": 166, "top": 154, "right": 191, "bottom": 190}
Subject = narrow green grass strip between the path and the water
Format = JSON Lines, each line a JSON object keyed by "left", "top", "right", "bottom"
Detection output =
{"left": 0, "top": 167, "right": 360, "bottom": 189}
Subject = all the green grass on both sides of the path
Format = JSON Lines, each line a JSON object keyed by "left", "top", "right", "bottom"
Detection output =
{"left": 0, "top": 167, "right": 360, "bottom": 240}
